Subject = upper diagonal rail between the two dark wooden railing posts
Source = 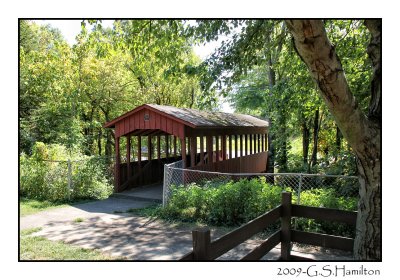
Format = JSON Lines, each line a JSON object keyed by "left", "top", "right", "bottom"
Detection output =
{"left": 209, "top": 206, "right": 281, "bottom": 259}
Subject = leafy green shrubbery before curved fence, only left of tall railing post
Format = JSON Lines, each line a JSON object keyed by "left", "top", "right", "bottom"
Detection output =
{"left": 161, "top": 178, "right": 282, "bottom": 226}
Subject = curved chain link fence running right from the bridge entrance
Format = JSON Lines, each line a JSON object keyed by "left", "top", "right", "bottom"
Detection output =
{"left": 163, "top": 161, "right": 359, "bottom": 206}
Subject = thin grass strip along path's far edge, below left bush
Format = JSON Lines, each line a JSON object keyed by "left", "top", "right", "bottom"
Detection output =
{"left": 19, "top": 197, "right": 94, "bottom": 217}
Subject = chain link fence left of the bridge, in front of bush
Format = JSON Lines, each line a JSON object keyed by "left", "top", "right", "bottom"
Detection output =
{"left": 19, "top": 156, "right": 114, "bottom": 201}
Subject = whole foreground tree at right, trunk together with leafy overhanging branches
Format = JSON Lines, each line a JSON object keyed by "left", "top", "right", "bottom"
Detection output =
{"left": 194, "top": 20, "right": 381, "bottom": 259}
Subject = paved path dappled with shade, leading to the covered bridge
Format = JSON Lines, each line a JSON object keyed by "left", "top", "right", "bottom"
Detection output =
{"left": 20, "top": 187, "right": 350, "bottom": 260}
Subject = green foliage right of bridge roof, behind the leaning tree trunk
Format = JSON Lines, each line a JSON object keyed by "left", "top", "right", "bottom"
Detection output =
{"left": 192, "top": 20, "right": 372, "bottom": 175}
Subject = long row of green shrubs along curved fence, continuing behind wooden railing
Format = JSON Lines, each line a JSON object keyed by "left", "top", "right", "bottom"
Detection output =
{"left": 159, "top": 177, "right": 357, "bottom": 236}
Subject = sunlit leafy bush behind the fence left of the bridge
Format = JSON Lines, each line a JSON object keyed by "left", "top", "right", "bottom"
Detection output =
{"left": 20, "top": 142, "right": 112, "bottom": 202}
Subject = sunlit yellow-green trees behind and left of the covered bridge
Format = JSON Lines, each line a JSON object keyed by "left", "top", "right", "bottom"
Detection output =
{"left": 19, "top": 20, "right": 211, "bottom": 157}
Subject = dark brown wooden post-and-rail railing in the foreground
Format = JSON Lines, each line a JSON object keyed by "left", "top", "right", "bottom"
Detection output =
{"left": 181, "top": 192, "right": 357, "bottom": 261}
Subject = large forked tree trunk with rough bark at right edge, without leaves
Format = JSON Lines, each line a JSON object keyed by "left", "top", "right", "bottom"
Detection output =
{"left": 286, "top": 20, "right": 382, "bottom": 260}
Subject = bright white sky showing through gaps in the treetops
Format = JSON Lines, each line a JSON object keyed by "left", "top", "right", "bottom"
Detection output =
{"left": 35, "top": 20, "right": 234, "bottom": 113}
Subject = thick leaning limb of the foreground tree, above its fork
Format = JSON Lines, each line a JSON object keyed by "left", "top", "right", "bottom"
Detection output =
{"left": 286, "top": 20, "right": 371, "bottom": 155}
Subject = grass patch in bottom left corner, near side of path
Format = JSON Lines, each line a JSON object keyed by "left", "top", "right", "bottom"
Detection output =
{"left": 20, "top": 228, "right": 121, "bottom": 260}
